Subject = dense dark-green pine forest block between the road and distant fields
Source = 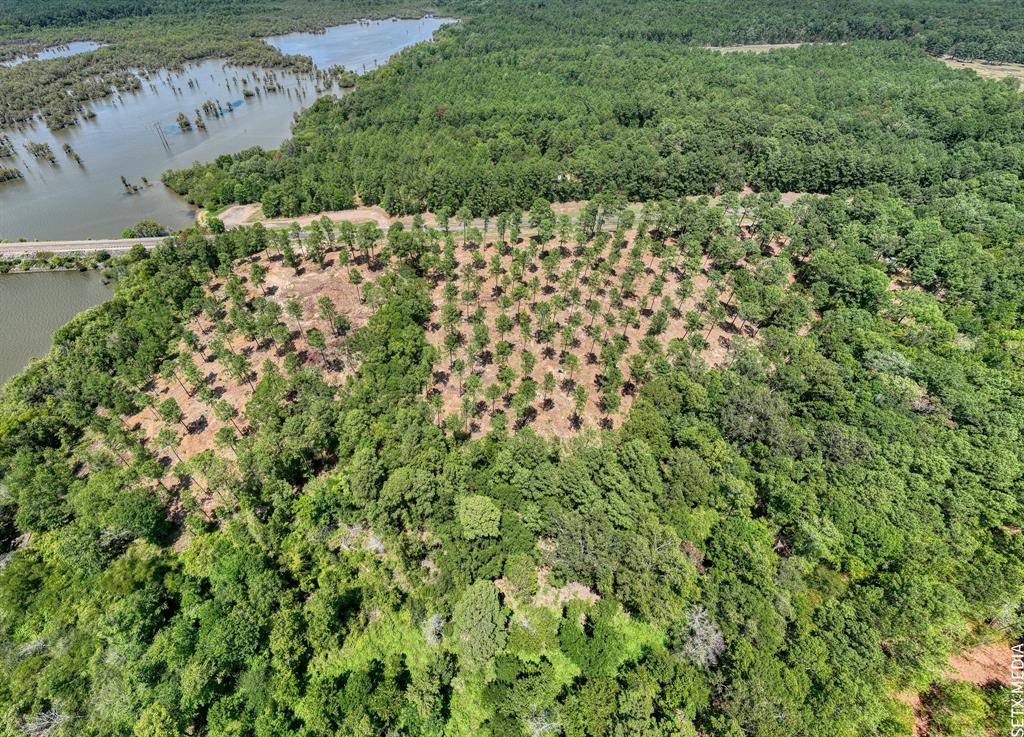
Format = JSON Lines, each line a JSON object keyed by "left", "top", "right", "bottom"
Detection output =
{"left": 164, "top": 2, "right": 1024, "bottom": 216}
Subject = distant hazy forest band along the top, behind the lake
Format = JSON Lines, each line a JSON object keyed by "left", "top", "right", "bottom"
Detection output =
{"left": 0, "top": 0, "right": 1024, "bottom": 128}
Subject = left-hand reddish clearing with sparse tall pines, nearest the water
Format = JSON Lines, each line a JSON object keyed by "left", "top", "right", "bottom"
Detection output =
{"left": 124, "top": 240, "right": 375, "bottom": 514}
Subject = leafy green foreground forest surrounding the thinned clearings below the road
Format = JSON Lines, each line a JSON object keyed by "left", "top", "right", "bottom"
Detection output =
{"left": 0, "top": 185, "right": 1024, "bottom": 737}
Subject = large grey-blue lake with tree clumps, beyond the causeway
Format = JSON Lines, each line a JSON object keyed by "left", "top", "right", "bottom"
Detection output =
{"left": 0, "top": 17, "right": 451, "bottom": 241}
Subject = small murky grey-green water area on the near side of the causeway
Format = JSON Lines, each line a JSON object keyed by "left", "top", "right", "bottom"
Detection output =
{"left": 0, "top": 271, "right": 112, "bottom": 382}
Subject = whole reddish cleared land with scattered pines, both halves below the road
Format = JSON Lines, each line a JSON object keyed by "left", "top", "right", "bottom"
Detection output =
{"left": 123, "top": 198, "right": 812, "bottom": 515}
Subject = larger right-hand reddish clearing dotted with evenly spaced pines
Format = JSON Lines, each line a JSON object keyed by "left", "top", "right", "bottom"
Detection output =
{"left": 427, "top": 229, "right": 792, "bottom": 436}
